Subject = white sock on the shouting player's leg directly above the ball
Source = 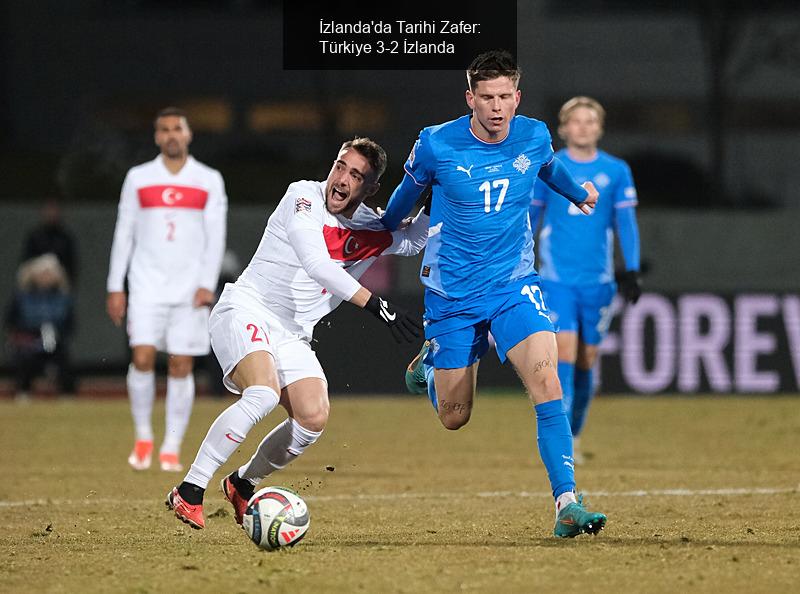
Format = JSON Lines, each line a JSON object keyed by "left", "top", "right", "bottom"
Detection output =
{"left": 239, "top": 419, "right": 322, "bottom": 485}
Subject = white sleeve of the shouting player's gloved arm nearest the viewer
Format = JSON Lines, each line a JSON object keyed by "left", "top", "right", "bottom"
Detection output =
{"left": 286, "top": 188, "right": 361, "bottom": 301}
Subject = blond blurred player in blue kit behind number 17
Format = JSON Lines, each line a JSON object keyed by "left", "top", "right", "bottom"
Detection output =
{"left": 530, "top": 97, "right": 642, "bottom": 463}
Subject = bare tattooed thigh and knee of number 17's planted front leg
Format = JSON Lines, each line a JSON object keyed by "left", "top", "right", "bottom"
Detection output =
{"left": 507, "top": 331, "right": 561, "bottom": 404}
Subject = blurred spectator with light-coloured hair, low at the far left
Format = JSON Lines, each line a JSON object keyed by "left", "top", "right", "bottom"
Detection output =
{"left": 6, "top": 254, "right": 75, "bottom": 400}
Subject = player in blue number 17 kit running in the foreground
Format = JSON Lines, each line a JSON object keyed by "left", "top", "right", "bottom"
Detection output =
{"left": 383, "top": 51, "right": 606, "bottom": 537}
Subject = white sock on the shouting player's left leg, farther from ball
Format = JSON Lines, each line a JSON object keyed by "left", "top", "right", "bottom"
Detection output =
{"left": 184, "top": 386, "right": 278, "bottom": 489}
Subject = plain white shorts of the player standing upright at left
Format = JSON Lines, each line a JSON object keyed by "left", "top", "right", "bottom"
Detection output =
{"left": 128, "top": 300, "right": 210, "bottom": 356}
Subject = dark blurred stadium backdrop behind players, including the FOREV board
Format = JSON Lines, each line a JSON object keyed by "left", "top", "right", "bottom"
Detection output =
{"left": 0, "top": 0, "right": 800, "bottom": 396}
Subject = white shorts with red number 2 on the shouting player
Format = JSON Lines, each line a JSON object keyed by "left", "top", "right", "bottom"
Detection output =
{"left": 208, "top": 285, "right": 328, "bottom": 394}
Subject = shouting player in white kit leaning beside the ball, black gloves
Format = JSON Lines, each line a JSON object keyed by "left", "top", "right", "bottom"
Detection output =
{"left": 166, "top": 138, "right": 428, "bottom": 528}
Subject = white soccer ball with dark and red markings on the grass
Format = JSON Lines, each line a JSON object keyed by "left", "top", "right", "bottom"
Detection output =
{"left": 242, "top": 487, "right": 309, "bottom": 551}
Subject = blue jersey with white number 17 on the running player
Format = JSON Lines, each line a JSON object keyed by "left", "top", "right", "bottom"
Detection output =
{"left": 384, "top": 115, "right": 566, "bottom": 299}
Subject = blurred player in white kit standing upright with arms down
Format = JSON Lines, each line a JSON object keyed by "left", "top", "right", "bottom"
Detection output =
{"left": 106, "top": 107, "right": 228, "bottom": 472}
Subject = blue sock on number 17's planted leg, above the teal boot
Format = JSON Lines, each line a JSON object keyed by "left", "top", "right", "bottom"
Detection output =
{"left": 535, "top": 400, "right": 575, "bottom": 497}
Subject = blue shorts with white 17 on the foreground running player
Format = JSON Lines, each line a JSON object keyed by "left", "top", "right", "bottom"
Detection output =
{"left": 425, "top": 275, "right": 555, "bottom": 369}
